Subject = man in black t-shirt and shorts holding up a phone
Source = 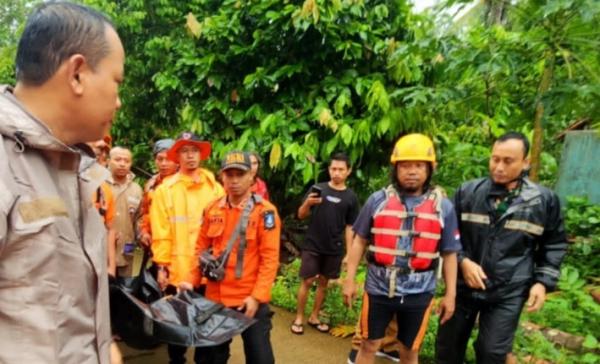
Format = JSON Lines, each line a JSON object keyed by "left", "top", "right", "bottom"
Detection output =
{"left": 290, "top": 153, "right": 359, "bottom": 335}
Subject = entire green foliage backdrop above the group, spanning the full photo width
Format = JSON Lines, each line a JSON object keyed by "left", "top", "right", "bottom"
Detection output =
{"left": 0, "top": 0, "right": 600, "bottom": 210}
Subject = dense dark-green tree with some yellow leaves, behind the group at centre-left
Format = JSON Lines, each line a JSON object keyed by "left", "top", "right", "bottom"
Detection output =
{"left": 79, "top": 0, "right": 446, "bottom": 211}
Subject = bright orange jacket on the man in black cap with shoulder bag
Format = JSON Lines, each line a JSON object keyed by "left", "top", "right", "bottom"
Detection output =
{"left": 197, "top": 197, "right": 281, "bottom": 307}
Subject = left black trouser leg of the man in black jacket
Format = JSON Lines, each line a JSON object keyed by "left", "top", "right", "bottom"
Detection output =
{"left": 435, "top": 296, "right": 479, "bottom": 364}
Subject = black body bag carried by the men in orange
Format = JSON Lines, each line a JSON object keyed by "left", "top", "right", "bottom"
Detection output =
{"left": 110, "top": 252, "right": 256, "bottom": 350}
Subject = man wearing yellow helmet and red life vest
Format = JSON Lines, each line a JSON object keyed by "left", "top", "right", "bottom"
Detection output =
{"left": 344, "top": 134, "right": 461, "bottom": 364}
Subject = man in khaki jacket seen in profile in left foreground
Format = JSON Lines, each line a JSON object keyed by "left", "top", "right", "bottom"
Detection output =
{"left": 0, "top": 2, "right": 125, "bottom": 364}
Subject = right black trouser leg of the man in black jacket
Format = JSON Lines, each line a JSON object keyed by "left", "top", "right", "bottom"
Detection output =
{"left": 475, "top": 296, "right": 526, "bottom": 364}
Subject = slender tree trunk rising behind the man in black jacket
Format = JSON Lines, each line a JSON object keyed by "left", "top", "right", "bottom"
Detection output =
{"left": 529, "top": 49, "right": 554, "bottom": 182}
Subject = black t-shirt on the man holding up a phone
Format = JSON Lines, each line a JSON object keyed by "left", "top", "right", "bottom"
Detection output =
{"left": 303, "top": 182, "right": 360, "bottom": 255}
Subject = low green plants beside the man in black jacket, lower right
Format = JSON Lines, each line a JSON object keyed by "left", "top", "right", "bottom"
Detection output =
{"left": 515, "top": 197, "right": 600, "bottom": 363}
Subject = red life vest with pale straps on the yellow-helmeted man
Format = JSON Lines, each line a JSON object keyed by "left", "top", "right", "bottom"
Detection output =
{"left": 369, "top": 187, "right": 442, "bottom": 271}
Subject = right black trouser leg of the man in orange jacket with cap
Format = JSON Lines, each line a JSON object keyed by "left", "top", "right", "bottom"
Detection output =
{"left": 242, "top": 303, "right": 275, "bottom": 364}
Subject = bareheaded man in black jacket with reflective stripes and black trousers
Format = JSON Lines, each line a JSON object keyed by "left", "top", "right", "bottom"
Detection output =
{"left": 436, "top": 132, "right": 567, "bottom": 364}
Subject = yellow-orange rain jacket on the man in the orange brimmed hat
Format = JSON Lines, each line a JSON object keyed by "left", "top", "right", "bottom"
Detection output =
{"left": 150, "top": 168, "right": 225, "bottom": 286}
